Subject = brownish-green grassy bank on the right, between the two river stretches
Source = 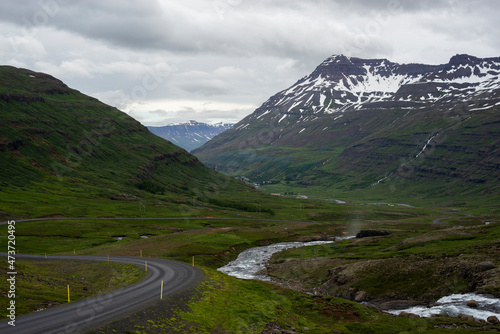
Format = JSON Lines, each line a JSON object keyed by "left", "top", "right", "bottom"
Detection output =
{"left": 271, "top": 217, "right": 500, "bottom": 303}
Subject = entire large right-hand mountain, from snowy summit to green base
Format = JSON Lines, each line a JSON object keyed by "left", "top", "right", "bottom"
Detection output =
{"left": 193, "top": 55, "right": 500, "bottom": 202}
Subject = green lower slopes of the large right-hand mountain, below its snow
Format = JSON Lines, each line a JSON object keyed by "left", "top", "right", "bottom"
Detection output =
{"left": 194, "top": 106, "right": 500, "bottom": 205}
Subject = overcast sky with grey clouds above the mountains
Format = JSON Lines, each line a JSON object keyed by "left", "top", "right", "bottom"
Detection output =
{"left": 0, "top": 0, "right": 500, "bottom": 125}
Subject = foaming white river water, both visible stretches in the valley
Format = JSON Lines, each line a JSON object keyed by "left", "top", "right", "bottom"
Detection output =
{"left": 217, "top": 237, "right": 500, "bottom": 320}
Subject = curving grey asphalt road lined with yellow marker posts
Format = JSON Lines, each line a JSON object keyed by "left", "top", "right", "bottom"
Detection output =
{"left": 0, "top": 253, "right": 203, "bottom": 334}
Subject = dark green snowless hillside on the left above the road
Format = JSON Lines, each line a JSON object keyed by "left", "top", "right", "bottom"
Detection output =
{"left": 0, "top": 66, "right": 251, "bottom": 219}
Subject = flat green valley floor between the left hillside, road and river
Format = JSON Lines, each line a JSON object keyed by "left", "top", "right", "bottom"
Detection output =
{"left": 0, "top": 198, "right": 438, "bottom": 267}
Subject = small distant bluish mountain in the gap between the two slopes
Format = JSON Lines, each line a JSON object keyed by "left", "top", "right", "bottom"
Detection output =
{"left": 148, "top": 121, "right": 233, "bottom": 151}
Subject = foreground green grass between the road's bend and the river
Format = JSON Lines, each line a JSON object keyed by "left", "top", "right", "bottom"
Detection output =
{"left": 154, "top": 269, "right": 490, "bottom": 334}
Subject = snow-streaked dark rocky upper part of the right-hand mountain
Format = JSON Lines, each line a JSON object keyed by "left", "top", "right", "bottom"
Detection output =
{"left": 235, "top": 55, "right": 500, "bottom": 129}
